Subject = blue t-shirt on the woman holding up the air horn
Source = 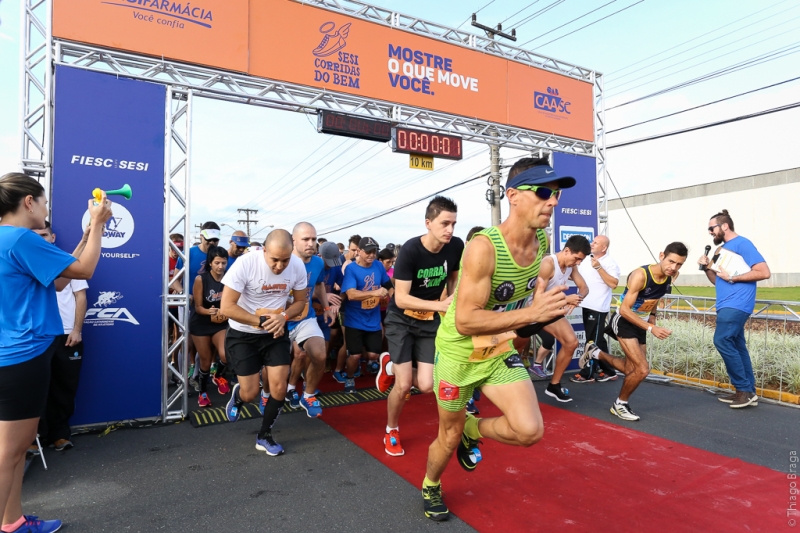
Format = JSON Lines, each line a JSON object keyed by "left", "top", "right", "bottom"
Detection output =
{"left": 0, "top": 226, "right": 75, "bottom": 366}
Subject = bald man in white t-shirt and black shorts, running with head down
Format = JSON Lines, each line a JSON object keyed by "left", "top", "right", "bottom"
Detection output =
{"left": 220, "top": 229, "right": 307, "bottom": 456}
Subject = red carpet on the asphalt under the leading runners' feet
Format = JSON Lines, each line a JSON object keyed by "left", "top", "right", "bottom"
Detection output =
{"left": 323, "top": 394, "right": 791, "bottom": 533}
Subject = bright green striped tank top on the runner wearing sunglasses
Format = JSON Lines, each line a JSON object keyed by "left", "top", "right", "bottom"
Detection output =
{"left": 436, "top": 226, "right": 547, "bottom": 363}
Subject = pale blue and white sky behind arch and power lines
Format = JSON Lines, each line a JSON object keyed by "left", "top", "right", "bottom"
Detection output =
{"left": 0, "top": 0, "right": 800, "bottom": 245}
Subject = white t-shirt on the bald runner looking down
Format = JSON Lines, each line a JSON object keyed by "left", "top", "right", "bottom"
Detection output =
{"left": 222, "top": 251, "right": 308, "bottom": 335}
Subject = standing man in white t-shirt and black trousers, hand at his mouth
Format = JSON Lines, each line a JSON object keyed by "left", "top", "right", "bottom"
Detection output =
{"left": 570, "top": 235, "right": 620, "bottom": 383}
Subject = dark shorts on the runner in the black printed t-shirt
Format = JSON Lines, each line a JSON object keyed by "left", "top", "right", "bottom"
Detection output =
{"left": 384, "top": 311, "right": 439, "bottom": 364}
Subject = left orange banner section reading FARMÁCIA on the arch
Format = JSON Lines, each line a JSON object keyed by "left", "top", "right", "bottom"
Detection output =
{"left": 53, "top": 0, "right": 249, "bottom": 72}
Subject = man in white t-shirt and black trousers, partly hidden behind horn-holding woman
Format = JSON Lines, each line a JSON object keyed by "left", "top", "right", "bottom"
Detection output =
{"left": 36, "top": 222, "right": 89, "bottom": 451}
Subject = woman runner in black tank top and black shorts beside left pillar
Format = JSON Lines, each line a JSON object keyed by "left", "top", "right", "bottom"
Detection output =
{"left": 189, "top": 246, "right": 230, "bottom": 407}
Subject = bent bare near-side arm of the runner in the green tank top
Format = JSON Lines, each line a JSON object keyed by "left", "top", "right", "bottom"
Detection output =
{"left": 455, "top": 235, "right": 566, "bottom": 335}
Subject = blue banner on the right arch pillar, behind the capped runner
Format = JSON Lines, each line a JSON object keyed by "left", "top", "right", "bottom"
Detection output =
{"left": 553, "top": 152, "right": 598, "bottom": 369}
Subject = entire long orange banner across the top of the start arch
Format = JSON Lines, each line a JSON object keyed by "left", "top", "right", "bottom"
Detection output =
{"left": 53, "top": 0, "right": 594, "bottom": 141}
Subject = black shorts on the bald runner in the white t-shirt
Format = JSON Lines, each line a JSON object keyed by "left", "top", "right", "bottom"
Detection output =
{"left": 225, "top": 328, "right": 292, "bottom": 376}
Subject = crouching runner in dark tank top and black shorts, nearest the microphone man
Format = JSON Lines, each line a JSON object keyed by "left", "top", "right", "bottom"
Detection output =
{"left": 579, "top": 242, "right": 688, "bottom": 420}
